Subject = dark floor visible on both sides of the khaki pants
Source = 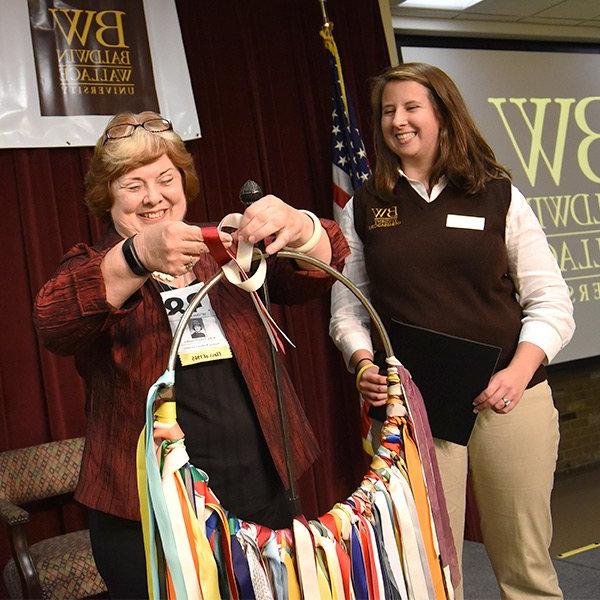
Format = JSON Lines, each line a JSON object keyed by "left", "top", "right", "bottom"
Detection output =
{"left": 463, "top": 467, "right": 600, "bottom": 600}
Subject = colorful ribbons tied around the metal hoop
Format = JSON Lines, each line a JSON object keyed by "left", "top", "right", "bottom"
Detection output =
{"left": 137, "top": 221, "right": 453, "bottom": 600}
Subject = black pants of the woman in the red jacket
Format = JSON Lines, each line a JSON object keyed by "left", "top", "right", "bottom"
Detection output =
{"left": 89, "top": 488, "right": 294, "bottom": 600}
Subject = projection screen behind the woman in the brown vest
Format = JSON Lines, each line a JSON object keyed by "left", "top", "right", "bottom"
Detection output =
{"left": 398, "top": 40, "right": 600, "bottom": 362}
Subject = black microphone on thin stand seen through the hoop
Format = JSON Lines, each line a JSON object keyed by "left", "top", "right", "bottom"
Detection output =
{"left": 240, "top": 180, "right": 302, "bottom": 516}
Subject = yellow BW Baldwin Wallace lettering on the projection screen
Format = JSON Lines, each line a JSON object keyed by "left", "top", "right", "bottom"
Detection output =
{"left": 488, "top": 96, "right": 600, "bottom": 303}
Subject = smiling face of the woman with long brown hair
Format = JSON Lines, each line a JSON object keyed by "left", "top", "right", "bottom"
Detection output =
{"left": 381, "top": 80, "right": 440, "bottom": 179}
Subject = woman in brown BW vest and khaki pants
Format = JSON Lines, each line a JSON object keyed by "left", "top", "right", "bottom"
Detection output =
{"left": 330, "top": 63, "right": 574, "bottom": 599}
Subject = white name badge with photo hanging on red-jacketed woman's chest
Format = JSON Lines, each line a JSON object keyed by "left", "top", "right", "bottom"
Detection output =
{"left": 160, "top": 283, "right": 233, "bottom": 366}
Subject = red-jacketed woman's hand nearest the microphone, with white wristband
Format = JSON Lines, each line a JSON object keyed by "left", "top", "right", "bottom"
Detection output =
{"left": 237, "top": 195, "right": 314, "bottom": 254}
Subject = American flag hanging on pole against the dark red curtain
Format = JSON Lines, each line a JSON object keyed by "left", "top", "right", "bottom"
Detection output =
{"left": 320, "top": 23, "right": 371, "bottom": 221}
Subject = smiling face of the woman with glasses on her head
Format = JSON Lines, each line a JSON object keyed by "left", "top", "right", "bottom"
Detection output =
{"left": 110, "top": 154, "right": 187, "bottom": 237}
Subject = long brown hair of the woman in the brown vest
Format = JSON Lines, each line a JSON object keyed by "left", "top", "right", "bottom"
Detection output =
{"left": 371, "top": 63, "right": 510, "bottom": 197}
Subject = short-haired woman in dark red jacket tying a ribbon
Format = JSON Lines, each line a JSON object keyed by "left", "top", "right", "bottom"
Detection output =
{"left": 34, "top": 112, "right": 348, "bottom": 598}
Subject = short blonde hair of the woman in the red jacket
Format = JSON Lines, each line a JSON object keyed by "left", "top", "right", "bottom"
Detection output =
{"left": 85, "top": 111, "right": 200, "bottom": 219}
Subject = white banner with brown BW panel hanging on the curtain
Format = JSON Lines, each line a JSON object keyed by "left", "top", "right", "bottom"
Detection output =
{"left": 0, "top": 0, "right": 200, "bottom": 148}
